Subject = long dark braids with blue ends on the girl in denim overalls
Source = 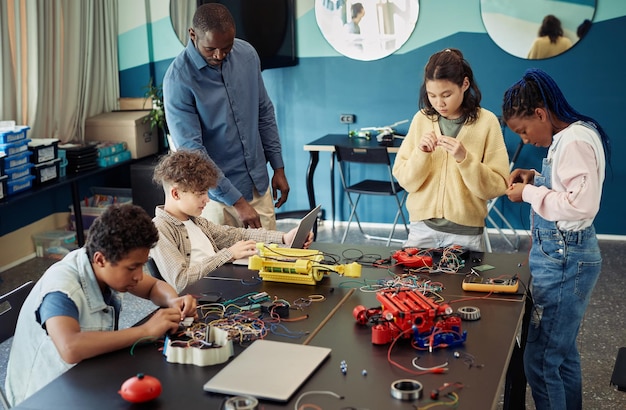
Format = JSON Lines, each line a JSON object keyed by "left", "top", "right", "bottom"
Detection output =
{"left": 502, "top": 68, "right": 611, "bottom": 163}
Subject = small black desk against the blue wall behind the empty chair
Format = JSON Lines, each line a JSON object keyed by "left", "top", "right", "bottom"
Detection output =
{"left": 304, "top": 134, "right": 402, "bottom": 227}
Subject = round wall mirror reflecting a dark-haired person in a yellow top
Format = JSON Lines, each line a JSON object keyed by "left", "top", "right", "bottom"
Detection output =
{"left": 480, "top": 0, "right": 596, "bottom": 59}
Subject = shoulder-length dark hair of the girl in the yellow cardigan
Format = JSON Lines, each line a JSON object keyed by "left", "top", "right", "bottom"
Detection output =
{"left": 419, "top": 48, "right": 482, "bottom": 124}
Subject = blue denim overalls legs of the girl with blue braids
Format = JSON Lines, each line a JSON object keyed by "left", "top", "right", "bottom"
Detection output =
{"left": 524, "top": 226, "right": 602, "bottom": 410}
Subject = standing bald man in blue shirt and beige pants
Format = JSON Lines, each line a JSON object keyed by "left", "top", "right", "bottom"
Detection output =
{"left": 163, "top": 3, "right": 289, "bottom": 230}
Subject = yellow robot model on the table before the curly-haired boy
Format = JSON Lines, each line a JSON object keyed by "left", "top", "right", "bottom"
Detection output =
{"left": 248, "top": 243, "right": 361, "bottom": 285}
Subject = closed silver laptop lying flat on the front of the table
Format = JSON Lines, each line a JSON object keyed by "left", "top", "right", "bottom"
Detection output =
{"left": 203, "top": 340, "right": 331, "bottom": 402}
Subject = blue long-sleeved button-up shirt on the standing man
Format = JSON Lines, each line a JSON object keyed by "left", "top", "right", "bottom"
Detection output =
{"left": 163, "top": 39, "right": 284, "bottom": 205}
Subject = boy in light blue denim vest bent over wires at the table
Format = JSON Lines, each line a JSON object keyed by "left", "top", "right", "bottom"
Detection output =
{"left": 6, "top": 205, "right": 196, "bottom": 405}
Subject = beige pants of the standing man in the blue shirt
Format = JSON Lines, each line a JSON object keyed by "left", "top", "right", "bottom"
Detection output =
{"left": 202, "top": 188, "right": 276, "bottom": 231}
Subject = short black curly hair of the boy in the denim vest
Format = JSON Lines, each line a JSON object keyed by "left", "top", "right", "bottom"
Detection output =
{"left": 85, "top": 204, "right": 159, "bottom": 264}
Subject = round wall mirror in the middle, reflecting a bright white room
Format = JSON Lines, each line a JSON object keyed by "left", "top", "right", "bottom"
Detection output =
{"left": 315, "top": 0, "right": 419, "bottom": 61}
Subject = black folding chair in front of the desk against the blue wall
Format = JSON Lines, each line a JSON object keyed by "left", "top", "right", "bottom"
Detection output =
{"left": 335, "top": 145, "right": 409, "bottom": 246}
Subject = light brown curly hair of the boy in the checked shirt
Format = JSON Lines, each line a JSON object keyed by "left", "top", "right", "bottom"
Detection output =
{"left": 152, "top": 150, "right": 219, "bottom": 192}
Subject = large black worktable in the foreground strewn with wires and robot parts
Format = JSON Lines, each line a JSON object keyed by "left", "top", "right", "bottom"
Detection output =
{"left": 15, "top": 243, "right": 529, "bottom": 410}
